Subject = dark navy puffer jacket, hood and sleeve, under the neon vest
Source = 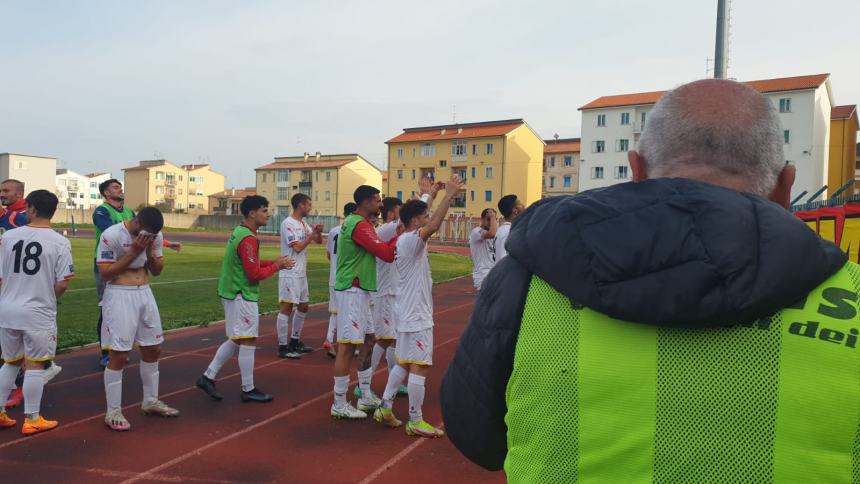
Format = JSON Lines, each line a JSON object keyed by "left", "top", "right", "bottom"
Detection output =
{"left": 442, "top": 179, "right": 846, "bottom": 470}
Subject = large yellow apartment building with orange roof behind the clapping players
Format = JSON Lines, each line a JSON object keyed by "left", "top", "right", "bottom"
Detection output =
{"left": 384, "top": 119, "right": 544, "bottom": 217}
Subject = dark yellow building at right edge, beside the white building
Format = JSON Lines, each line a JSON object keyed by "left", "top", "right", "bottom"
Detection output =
{"left": 827, "top": 105, "right": 860, "bottom": 197}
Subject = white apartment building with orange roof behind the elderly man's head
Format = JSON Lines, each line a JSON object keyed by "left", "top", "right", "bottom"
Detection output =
{"left": 579, "top": 74, "right": 833, "bottom": 201}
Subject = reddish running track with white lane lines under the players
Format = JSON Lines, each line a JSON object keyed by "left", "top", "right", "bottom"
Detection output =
{"left": 0, "top": 278, "right": 504, "bottom": 484}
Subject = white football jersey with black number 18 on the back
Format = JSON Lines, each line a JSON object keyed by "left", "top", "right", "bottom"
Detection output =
{"left": 0, "top": 225, "right": 74, "bottom": 330}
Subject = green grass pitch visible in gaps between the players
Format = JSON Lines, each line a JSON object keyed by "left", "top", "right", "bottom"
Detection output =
{"left": 57, "top": 239, "right": 472, "bottom": 348}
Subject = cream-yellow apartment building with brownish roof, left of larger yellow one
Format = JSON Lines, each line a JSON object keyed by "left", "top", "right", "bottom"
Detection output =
{"left": 256, "top": 152, "right": 384, "bottom": 215}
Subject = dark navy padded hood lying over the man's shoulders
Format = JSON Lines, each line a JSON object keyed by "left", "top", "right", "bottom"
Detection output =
{"left": 506, "top": 179, "right": 847, "bottom": 327}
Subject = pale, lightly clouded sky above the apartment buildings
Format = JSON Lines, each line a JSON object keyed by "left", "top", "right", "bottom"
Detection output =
{"left": 0, "top": 0, "right": 860, "bottom": 187}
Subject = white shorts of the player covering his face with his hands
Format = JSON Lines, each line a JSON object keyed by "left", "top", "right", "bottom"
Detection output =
{"left": 102, "top": 284, "right": 164, "bottom": 351}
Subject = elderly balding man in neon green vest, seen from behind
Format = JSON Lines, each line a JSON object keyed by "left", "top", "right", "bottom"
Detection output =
{"left": 442, "top": 80, "right": 860, "bottom": 483}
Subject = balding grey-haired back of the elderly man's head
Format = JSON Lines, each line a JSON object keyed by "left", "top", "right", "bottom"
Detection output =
{"left": 639, "top": 80, "right": 785, "bottom": 197}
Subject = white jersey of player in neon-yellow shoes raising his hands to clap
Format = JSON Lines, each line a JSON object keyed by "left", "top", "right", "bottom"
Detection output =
{"left": 394, "top": 230, "right": 433, "bottom": 332}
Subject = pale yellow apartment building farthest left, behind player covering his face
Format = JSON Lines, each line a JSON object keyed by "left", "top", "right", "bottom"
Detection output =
{"left": 123, "top": 160, "right": 224, "bottom": 214}
